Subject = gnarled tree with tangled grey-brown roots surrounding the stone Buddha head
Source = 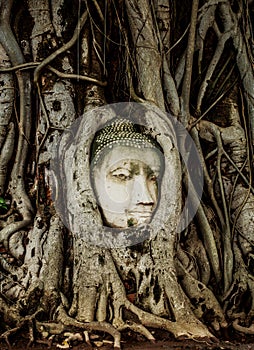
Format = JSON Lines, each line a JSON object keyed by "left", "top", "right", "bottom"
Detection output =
{"left": 0, "top": 0, "right": 254, "bottom": 348}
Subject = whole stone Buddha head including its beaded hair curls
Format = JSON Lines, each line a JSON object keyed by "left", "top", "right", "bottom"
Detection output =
{"left": 91, "top": 122, "right": 164, "bottom": 228}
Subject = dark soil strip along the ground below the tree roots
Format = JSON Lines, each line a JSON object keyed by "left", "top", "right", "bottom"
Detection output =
{"left": 0, "top": 332, "right": 254, "bottom": 350}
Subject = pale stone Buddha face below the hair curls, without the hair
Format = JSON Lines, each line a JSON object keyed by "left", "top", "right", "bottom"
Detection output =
{"left": 92, "top": 145, "right": 163, "bottom": 228}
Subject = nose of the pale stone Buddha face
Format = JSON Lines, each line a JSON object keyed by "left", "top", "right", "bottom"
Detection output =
{"left": 132, "top": 175, "right": 154, "bottom": 205}
